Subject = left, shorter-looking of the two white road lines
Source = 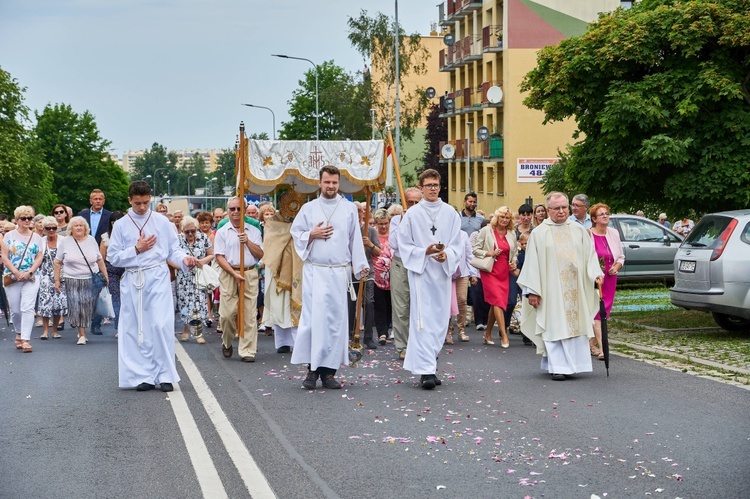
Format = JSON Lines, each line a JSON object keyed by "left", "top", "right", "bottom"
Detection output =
{"left": 169, "top": 384, "right": 228, "bottom": 499}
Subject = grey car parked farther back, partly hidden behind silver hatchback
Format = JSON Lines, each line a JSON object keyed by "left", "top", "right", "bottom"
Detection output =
{"left": 609, "top": 214, "right": 683, "bottom": 282}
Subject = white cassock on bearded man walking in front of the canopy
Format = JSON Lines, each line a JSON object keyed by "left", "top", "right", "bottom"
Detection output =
{"left": 291, "top": 195, "right": 370, "bottom": 371}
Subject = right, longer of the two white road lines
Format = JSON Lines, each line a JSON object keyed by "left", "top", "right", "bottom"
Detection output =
{"left": 175, "top": 342, "right": 276, "bottom": 499}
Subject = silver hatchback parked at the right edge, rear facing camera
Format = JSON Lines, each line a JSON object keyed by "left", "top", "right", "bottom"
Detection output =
{"left": 669, "top": 209, "right": 750, "bottom": 331}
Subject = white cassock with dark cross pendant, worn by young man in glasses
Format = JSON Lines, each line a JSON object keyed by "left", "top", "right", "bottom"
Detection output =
{"left": 398, "top": 200, "right": 464, "bottom": 374}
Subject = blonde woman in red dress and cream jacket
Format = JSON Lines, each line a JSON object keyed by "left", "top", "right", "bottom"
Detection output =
{"left": 474, "top": 206, "right": 517, "bottom": 348}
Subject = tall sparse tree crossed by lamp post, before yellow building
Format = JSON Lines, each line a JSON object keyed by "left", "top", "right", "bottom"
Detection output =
{"left": 347, "top": 10, "right": 430, "bottom": 140}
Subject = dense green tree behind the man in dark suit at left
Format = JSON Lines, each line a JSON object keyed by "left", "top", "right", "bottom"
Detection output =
{"left": 35, "top": 104, "right": 128, "bottom": 211}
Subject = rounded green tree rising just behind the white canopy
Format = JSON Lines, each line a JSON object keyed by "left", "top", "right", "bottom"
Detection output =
{"left": 279, "top": 61, "right": 371, "bottom": 140}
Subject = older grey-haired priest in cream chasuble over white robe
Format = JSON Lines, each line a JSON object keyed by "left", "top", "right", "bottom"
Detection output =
{"left": 518, "top": 192, "right": 603, "bottom": 381}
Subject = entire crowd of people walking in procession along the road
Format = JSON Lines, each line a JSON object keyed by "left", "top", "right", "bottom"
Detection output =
{"left": 0, "top": 174, "right": 693, "bottom": 391}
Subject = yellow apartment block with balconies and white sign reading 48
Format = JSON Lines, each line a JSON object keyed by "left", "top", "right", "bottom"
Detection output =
{"left": 435, "top": 0, "right": 620, "bottom": 211}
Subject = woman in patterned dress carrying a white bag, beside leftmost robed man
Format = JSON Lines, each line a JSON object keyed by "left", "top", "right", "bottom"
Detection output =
{"left": 177, "top": 216, "right": 214, "bottom": 344}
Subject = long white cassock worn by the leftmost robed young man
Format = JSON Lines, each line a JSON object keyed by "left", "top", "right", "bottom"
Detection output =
{"left": 107, "top": 209, "right": 188, "bottom": 388}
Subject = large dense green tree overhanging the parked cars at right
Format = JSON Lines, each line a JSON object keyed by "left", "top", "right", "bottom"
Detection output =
{"left": 521, "top": 0, "right": 750, "bottom": 216}
